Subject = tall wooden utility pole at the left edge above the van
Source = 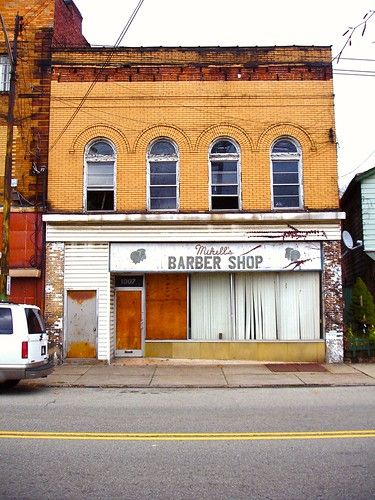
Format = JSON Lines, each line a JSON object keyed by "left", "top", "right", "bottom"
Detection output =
{"left": 0, "top": 14, "right": 21, "bottom": 302}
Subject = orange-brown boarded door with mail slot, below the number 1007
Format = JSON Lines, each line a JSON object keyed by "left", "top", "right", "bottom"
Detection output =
{"left": 116, "top": 290, "right": 142, "bottom": 356}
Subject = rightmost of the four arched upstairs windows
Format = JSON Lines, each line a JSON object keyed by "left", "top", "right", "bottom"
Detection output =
{"left": 271, "top": 138, "right": 303, "bottom": 209}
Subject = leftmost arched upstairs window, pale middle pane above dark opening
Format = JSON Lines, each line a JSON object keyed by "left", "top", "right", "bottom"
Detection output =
{"left": 85, "top": 139, "right": 116, "bottom": 212}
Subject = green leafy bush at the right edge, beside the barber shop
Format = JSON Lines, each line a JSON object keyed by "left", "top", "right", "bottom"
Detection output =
{"left": 349, "top": 278, "right": 375, "bottom": 337}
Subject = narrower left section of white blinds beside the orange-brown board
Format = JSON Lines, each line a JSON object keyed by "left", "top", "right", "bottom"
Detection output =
{"left": 190, "top": 273, "right": 232, "bottom": 340}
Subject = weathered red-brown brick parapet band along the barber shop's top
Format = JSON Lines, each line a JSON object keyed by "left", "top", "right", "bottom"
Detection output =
{"left": 53, "top": 47, "right": 332, "bottom": 82}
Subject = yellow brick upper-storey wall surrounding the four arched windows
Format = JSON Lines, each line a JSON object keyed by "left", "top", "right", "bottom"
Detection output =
{"left": 48, "top": 80, "right": 338, "bottom": 212}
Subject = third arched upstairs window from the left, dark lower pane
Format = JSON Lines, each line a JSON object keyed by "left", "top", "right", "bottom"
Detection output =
{"left": 209, "top": 139, "right": 240, "bottom": 210}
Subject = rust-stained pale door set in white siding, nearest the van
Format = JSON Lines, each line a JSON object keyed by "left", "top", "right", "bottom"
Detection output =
{"left": 66, "top": 290, "right": 97, "bottom": 358}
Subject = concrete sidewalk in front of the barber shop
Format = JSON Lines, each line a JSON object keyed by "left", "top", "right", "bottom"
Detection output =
{"left": 21, "top": 358, "right": 375, "bottom": 388}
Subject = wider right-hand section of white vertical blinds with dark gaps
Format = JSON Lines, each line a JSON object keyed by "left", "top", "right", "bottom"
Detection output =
{"left": 234, "top": 272, "right": 320, "bottom": 340}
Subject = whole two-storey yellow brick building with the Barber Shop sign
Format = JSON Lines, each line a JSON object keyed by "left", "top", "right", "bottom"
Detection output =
{"left": 44, "top": 38, "right": 344, "bottom": 362}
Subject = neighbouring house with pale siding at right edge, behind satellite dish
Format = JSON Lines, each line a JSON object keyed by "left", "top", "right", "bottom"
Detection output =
{"left": 341, "top": 168, "right": 375, "bottom": 318}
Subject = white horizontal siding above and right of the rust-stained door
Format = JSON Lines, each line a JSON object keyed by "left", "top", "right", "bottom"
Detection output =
{"left": 64, "top": 243, "right": 110, "bottom": 360}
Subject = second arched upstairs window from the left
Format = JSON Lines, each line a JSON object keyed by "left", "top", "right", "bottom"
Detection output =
{"left": 147, "top": 139, "right": 178, "bottom": 210}
